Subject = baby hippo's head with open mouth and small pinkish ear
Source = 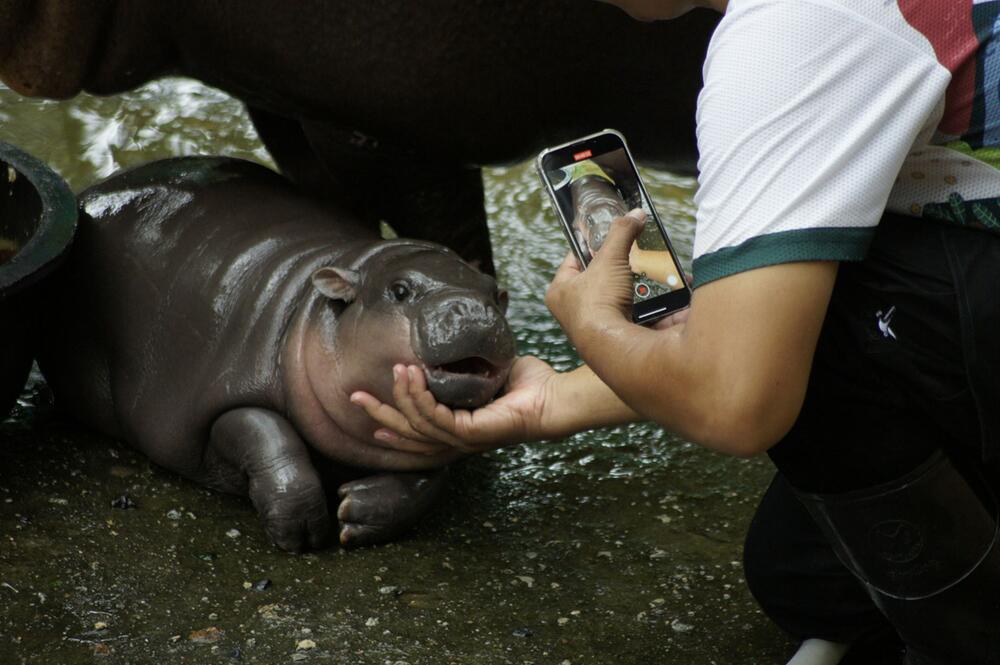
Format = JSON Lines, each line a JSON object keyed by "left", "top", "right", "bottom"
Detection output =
{"left": 312, "top": 240, "right": 515, "bottom": 420}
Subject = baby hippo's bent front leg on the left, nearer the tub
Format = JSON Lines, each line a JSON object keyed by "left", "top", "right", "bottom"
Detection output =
{"left": 206, "top": 408, "right": 331, "bottom": 552}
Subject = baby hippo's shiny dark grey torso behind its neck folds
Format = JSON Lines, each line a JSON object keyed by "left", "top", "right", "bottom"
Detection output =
{"left": 39, "top": 158, "right": 371, "bottom": 464}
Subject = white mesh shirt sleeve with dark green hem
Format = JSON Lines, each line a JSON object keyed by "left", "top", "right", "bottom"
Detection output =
{"left": 694, "top": 0, "right": 951, "bottom": 287}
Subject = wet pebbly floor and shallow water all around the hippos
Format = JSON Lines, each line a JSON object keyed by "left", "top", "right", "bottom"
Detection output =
{"left": 0, "top": 79, "right": 791, "bottom": 665}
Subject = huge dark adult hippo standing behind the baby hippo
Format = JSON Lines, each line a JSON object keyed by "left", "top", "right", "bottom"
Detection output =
{"left": 0, "top": 0, "right": 718, "bottom": 268}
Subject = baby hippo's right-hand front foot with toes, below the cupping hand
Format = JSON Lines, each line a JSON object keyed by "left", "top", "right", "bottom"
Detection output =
{"left": 337, "top": 470, "right": 447, "bottom": 547}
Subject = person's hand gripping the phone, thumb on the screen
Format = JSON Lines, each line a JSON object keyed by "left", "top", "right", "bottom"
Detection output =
{"left": 545, "top": 209, "right": 646, "bottom": 348}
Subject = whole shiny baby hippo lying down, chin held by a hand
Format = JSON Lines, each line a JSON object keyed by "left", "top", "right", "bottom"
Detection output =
{"left": 39, "top": 158, "right": 514, "bottom": 549}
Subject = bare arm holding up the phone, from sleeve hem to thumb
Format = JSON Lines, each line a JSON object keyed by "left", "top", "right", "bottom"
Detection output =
{"left": 547, "top": 219, "right": 837, "bottom": 456}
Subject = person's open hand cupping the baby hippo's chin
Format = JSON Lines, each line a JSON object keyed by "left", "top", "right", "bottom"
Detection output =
{"left": 351, "top": 356, "right": 557, "bottom": 453}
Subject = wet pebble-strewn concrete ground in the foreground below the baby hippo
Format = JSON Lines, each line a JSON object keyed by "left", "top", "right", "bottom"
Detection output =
{"left": 0, "top": 376, "right": 790, "bottom": 665}
